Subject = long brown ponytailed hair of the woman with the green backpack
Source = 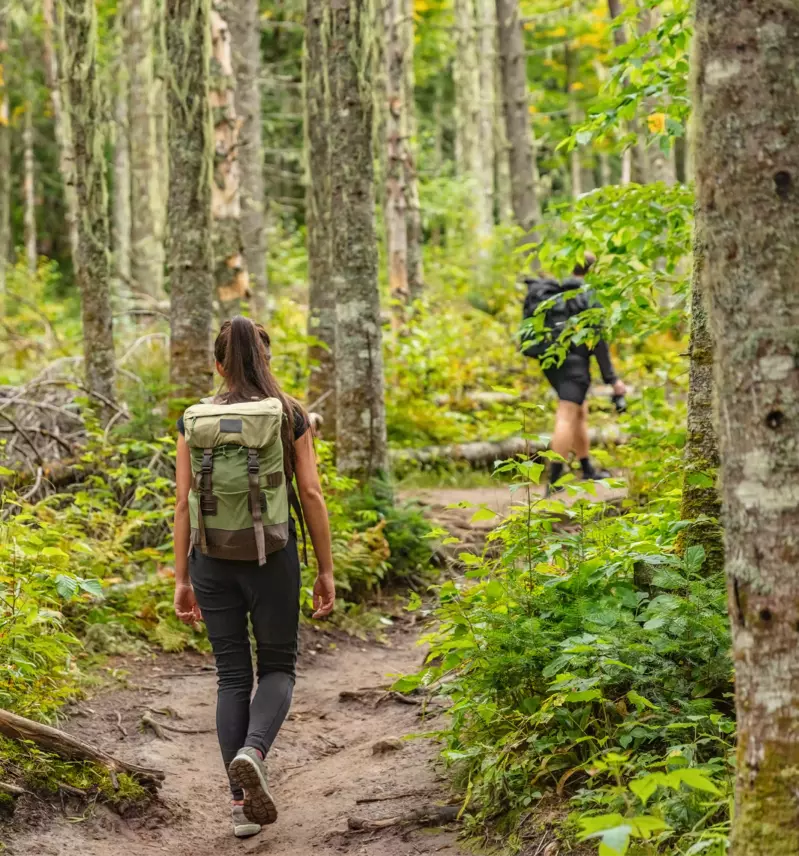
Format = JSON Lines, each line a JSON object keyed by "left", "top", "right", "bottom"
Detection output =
{"left": 214, "top": 315, "right": 308, "bottom": 481}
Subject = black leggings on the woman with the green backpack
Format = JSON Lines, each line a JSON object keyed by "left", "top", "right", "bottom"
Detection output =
{"left": 189, "top": 533, "right": 300, "bottom": 799}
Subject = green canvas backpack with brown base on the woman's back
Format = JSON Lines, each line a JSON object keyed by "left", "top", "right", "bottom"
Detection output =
{"left": 183, "top": 398, "right": 304, "bottom": 565}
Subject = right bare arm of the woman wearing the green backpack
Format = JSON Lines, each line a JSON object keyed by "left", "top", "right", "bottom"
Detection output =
{"left": 294, "top": 429, "right": 336, "bottom": 618}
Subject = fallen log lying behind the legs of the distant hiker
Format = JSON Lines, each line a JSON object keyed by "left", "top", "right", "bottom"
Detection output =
{"left": 391, "top": 426, "right": 626, "bottom": 467}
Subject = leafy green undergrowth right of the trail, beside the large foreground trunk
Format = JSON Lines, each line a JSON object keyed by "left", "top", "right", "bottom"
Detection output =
{"left": 406, "top": 438, "right": 734, "bottom": 856}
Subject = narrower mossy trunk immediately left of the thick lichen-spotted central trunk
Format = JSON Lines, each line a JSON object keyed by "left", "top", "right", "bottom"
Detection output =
{"left": 302, "top": 0, "right": 336, "bottom": 438}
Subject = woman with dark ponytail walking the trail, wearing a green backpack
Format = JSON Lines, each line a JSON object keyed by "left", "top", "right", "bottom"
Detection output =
{"left": 174, "top": 317, "right": 335, "bottom": 838}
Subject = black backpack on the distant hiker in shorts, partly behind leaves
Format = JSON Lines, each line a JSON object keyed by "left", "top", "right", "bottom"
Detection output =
{"left": 521, "top": 279, "right": 591, "bottom": 359}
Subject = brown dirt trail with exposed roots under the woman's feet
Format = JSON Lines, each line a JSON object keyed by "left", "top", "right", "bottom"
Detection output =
{"left": 0, "top": 487, "right": 623, "bottom": 856}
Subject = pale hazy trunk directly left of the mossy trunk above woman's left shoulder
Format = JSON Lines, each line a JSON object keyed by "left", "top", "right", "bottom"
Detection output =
{"left": 123, "top": 0, "right": 164, "bottom": 300}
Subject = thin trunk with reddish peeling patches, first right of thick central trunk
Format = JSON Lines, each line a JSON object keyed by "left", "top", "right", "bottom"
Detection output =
{"left": 383, "top": 0, "right": 410, "bottom": 310}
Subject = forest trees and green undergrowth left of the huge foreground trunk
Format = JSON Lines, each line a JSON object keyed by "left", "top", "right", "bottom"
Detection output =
{"left": 0, "top": 0, "right": 764, "bottom": 856}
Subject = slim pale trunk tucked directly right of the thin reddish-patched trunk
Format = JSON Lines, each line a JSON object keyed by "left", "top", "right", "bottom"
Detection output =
{"left": 402, "top": 0, "right": 424, "bottom": 300}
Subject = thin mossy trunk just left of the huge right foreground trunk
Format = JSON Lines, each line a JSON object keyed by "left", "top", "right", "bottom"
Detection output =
{"left": 680, "top": 211, "right": 724, "bottom": 574}
